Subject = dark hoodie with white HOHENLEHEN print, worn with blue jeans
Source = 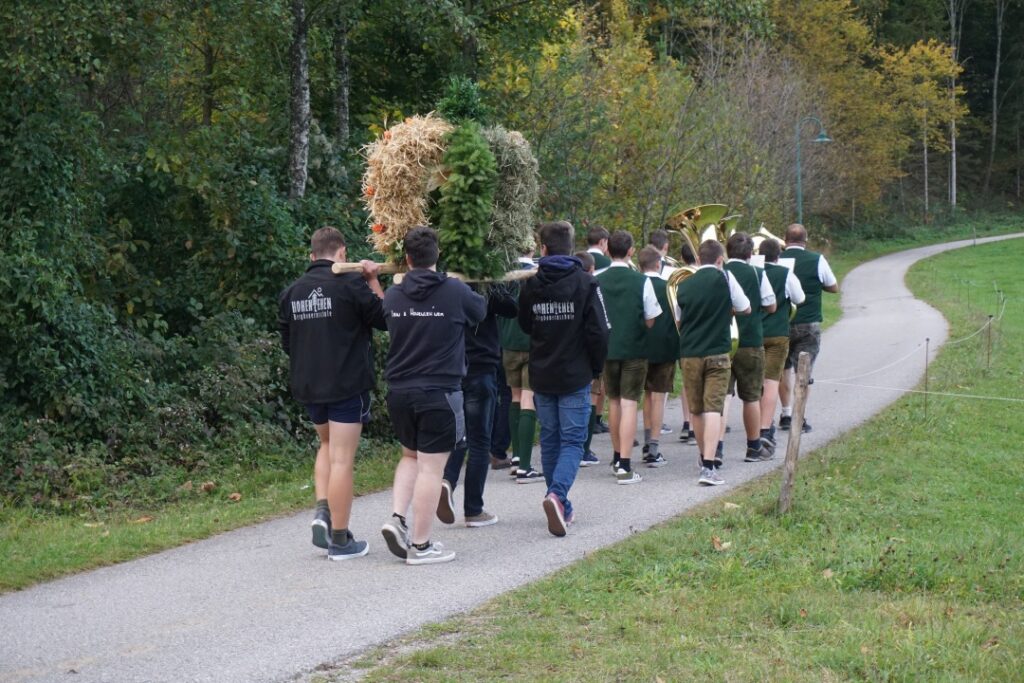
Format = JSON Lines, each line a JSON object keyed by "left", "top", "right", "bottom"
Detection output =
{"left": 519, "top": 256, "right": 610, "bottom": 394}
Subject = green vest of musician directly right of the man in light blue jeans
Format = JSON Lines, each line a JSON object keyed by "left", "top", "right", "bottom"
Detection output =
{"left": 597, "top": 266, "right": 647, "bottom": 360}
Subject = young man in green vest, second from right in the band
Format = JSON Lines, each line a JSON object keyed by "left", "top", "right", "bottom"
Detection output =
{"left": 758, "top": 240, "right": 805, "bottom": 453}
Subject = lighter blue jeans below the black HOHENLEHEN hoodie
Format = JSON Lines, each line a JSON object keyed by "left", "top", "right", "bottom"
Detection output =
{"left": 534, "top": 384, "right": 590, "bottom": 517}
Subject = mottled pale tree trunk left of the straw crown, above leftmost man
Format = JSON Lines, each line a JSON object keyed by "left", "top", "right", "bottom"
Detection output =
{"left": 288, "top": 0, "right": 310, "bottom": 200}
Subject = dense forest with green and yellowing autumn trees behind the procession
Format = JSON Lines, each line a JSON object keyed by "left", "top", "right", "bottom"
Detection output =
{"left": 0, "top": 0, "right": 1024, "bottom": 511}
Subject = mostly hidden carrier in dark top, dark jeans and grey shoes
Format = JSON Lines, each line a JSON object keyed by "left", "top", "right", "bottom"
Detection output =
{"left": 437, "top": 286, "right": 516, "bottom": 527}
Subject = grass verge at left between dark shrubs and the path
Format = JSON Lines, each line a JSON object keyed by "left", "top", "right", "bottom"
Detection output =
{"left": 0, "top": 442, "right": 397, "bottom": 592}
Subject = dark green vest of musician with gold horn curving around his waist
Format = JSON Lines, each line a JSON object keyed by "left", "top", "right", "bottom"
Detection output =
{"left": 676, "top": 268, "right": 732, "bottom": 358}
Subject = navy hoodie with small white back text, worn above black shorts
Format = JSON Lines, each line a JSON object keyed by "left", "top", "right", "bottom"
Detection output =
{"left": 384, "top": 268, "right": 487, "bottom": 391}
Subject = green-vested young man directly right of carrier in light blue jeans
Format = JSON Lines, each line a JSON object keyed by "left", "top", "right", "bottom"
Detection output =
{"left": 597, "top": 230, "right": 662, "bottom": 484}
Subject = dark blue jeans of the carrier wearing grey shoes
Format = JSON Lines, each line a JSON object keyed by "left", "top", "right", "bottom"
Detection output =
{"left": 444, "top": 370, "right": 498, "bottom": 517}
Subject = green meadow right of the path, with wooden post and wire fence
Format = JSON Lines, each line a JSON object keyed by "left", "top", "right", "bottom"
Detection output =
{"left": 342, "top": 241, "right": 1024, "bottom": 681}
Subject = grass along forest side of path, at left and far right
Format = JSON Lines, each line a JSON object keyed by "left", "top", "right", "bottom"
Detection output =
{"left": 0, "top": 216, "right": 1024, "bottom": 592}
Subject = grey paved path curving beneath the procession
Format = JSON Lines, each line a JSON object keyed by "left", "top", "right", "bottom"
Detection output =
{"left": 0, "top": 236, "right": 1024, "bottom": 683}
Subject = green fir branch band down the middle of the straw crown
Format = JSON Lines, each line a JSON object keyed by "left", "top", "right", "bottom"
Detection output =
{"left": 437, "top": 121, "right": 505, "bottom": 279}
